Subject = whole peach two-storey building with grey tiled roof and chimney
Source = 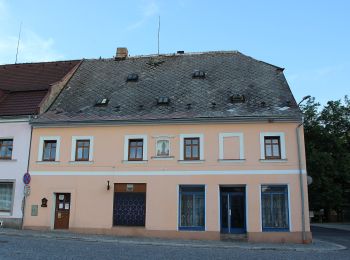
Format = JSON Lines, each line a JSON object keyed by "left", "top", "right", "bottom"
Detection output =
{"left": 24, "top": 49, "right": 311, "bottom": 242}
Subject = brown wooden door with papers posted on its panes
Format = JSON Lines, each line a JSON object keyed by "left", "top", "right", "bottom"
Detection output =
{"left": 55, "top": 193, "right": 70, "bottom": 229}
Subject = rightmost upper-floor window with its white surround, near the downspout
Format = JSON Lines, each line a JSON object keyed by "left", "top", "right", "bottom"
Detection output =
{"left": 260, "top": 132, "right": 287, "bottom": 161}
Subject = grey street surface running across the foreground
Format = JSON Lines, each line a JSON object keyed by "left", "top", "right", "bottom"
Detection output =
{"left": 0, "top": 227, "right": 350, "bottom": 260}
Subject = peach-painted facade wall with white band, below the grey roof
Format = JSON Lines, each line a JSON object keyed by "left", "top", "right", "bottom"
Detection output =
{"left": 24, "top": 123, "right": 311, "bottom": 242}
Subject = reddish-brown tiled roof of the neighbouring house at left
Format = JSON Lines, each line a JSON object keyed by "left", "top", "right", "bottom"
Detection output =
{"left": 0, "top": 60, "right": 80, "bottom": 116}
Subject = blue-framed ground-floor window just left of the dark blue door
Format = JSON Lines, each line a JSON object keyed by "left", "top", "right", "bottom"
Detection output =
{"left": 179, "top": 185, "right": 205, "bottom": 230}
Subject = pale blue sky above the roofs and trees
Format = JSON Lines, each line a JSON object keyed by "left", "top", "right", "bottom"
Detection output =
{"left": 0, "top": 0, "right": 350, "bottom": 104}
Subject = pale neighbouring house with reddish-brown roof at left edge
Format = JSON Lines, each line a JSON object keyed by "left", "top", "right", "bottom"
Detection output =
{"left": 0, "top": 61, "right": 78, "bottom": 228}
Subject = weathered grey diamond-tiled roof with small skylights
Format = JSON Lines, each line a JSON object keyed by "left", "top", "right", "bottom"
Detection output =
{"left": 33, "top": 52, "right": 301, "bottom": 123}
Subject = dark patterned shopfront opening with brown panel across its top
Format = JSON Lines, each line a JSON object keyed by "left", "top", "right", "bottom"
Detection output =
{"left": 113, "top": 184, "right": 146, "bottom": 226}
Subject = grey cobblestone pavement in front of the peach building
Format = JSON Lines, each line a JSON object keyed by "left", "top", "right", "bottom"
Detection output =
{"left": 0, "top": 228, "right": 350, "bottom": 260}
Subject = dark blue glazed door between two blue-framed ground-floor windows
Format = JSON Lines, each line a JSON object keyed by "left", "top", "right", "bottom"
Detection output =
{"left": 220, "top": 187, "right": 246, "bottom": 234}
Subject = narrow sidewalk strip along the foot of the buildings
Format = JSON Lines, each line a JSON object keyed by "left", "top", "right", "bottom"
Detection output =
{"left": 0, "top": 229, "right": 346, "bottom": 252}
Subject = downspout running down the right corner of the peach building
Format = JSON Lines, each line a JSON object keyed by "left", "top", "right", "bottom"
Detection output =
{"left": 295, "top": 122, "right": 307, "bottom": 244}
